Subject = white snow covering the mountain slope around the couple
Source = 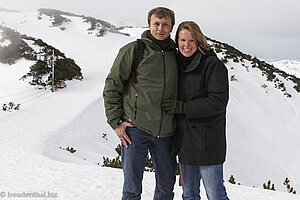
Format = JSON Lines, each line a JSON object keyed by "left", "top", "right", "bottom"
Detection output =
{"left": 0, "top": 9, "right": 300, "bottom": 200}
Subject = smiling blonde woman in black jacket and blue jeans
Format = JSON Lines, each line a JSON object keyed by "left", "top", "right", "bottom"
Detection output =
{"left": 162, "top": 21, "right": 229, "bottom": 200}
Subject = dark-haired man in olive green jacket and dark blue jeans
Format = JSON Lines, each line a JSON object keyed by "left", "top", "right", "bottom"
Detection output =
{"left": 103, "top": 7, "right": 178, "bottom": 200}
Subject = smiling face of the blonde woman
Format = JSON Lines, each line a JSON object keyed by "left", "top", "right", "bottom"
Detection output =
{"left": 178, "top": 29, "right": 197, "bottom": 57}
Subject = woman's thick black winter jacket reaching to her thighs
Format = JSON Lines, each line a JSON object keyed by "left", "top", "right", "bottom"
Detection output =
{"left": 174, "top": 50, "right": 229, "bottom": 165}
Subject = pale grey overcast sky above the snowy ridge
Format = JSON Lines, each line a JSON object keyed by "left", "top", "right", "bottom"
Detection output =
{"left": 0, "top": 0, "right": 300, "bottom": 61}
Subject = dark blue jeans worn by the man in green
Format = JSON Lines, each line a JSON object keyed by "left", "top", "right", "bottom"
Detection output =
{"left": 121, "top": 127, "right": 176, "bottom": 200}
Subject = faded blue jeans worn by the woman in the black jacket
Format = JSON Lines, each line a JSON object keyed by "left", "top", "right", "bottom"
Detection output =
{"left": 181, "top": 164, "right": 229, "bottom": 200}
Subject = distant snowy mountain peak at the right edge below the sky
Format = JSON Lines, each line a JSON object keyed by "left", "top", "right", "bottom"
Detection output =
{"left": 271, "top": 60, "right": 300, "bottom": 78}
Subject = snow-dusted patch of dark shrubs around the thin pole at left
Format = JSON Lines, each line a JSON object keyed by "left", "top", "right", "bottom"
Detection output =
{"left": 0, "top": 26, "right": 83, "bottom": 89}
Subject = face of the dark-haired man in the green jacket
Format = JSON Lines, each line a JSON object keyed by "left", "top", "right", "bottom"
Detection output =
{"left": 149, "top": 15, "right": 172, "bottom": 40}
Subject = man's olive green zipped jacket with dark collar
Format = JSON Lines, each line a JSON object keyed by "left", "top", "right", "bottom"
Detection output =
{"left": 103, "top": 31, "right": 178, "bottom": 137}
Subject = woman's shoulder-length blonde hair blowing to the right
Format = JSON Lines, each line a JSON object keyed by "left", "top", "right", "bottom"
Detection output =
{"left": 175, "top": 21, "right": 214, "bottom": 54}
